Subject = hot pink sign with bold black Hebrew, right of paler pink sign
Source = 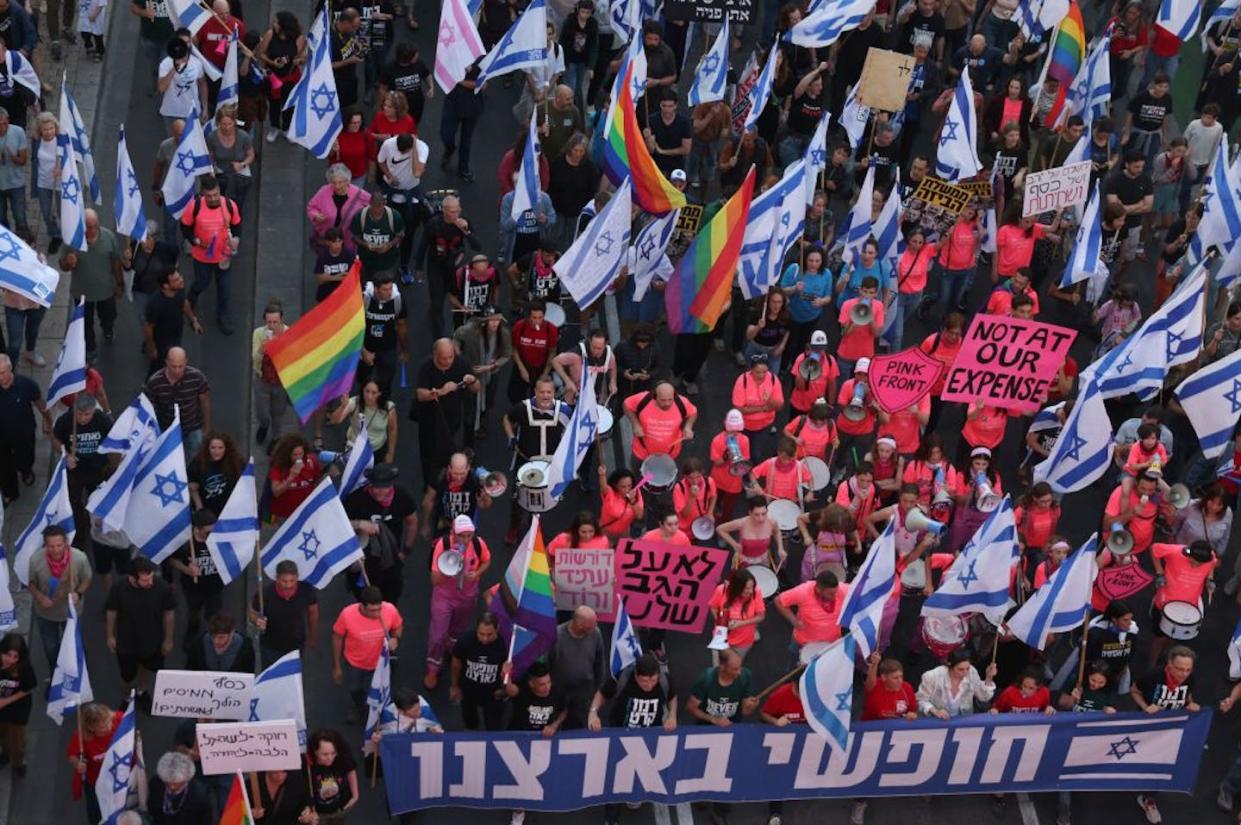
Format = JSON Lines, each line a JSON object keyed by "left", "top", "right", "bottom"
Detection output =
{"left": 616, "top": 538, "right": 730, "bottom": 634}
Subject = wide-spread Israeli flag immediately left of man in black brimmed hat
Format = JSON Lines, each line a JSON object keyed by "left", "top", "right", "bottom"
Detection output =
{"left": 259, "top": 478, "right": 362, "bottom": 591}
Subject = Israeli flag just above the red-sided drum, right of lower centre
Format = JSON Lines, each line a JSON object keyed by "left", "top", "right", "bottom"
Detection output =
{"left": 922, "top": 496, "right": 1021, "bottom": 617}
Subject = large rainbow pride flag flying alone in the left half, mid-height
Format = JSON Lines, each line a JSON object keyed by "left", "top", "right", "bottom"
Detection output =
{"left": 267, "top": 261, "right": 366, "bottom": 424}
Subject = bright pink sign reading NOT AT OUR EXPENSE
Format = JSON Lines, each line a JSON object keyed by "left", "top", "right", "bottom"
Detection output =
{"left": 939, "top": 315, "right": 1077, "bottom": 412}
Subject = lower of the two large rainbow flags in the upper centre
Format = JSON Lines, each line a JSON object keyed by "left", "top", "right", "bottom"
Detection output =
{"left": 664, "top": 166, "right": 755, "bottom": 335}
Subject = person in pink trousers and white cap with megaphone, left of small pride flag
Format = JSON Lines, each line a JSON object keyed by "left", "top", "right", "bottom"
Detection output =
{"left": 422, "top": 516, "right": 491, "bottom": 690}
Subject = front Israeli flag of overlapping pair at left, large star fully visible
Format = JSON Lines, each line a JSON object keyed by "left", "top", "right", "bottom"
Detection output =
{"left": 123, "top": 407, "right": 190, "bottom": 564}
